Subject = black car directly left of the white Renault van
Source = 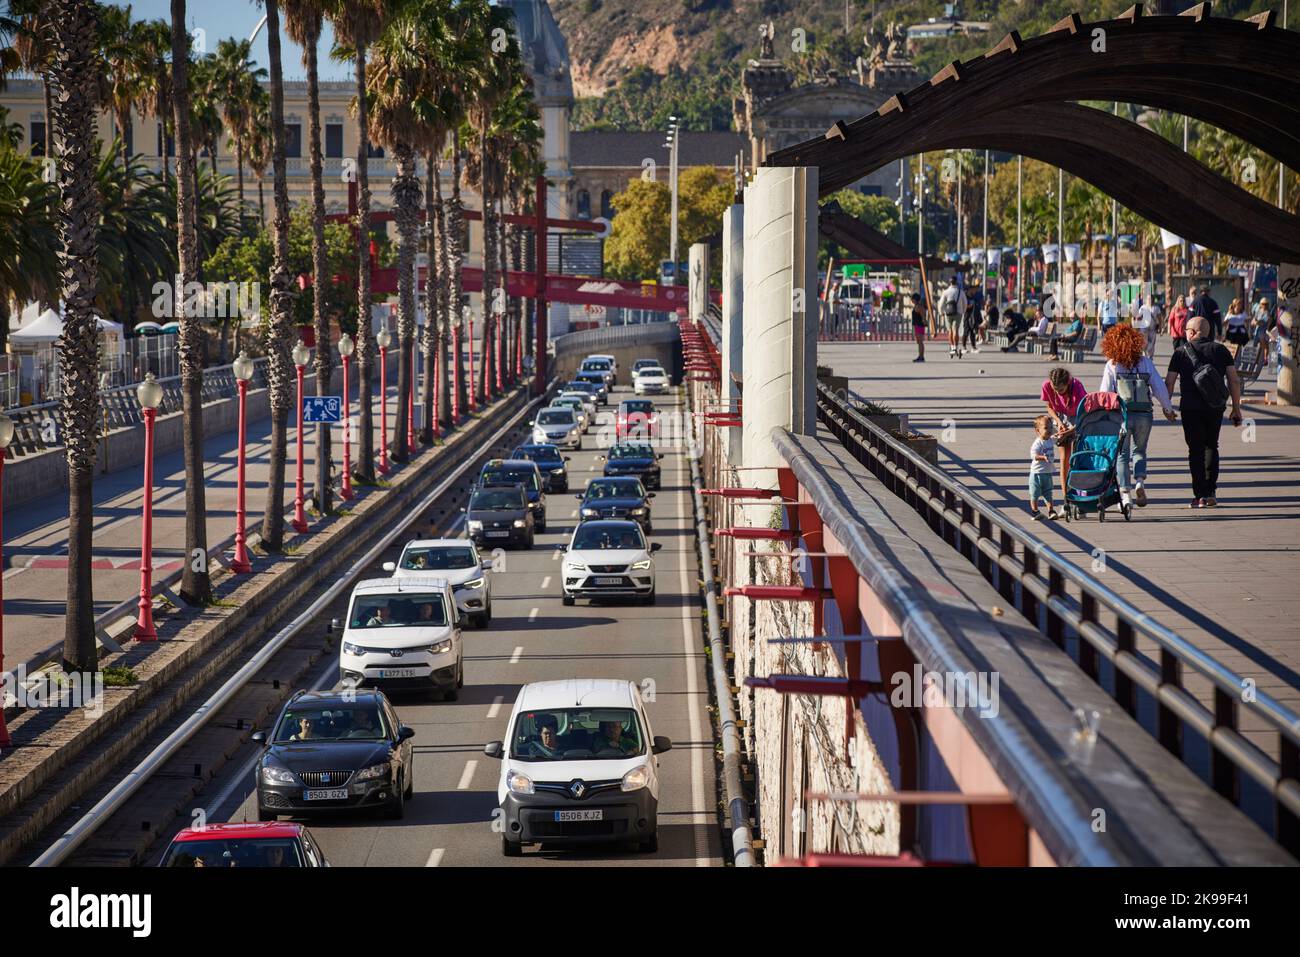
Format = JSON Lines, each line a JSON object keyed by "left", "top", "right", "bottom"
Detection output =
{"left": 252, "top": 688, "right": 415, "bottom": 820}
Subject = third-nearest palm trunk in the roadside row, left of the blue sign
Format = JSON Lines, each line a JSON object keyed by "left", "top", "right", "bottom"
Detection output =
{"left": 261, "top": 0, "right": 294, "bottom": 551}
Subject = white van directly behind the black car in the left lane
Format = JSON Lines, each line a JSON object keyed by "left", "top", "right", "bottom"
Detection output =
{"left": 330, "top": 575, "right": 465, "bottom": 701}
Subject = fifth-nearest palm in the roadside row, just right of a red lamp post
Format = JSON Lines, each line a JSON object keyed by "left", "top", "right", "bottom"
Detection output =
{"left": 326, "top": 0, "right": 387, "bottom": 481}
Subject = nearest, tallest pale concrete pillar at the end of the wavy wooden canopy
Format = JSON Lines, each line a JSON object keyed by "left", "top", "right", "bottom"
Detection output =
{"left": 742, "top": 166, "right": 818, "bottom": 486}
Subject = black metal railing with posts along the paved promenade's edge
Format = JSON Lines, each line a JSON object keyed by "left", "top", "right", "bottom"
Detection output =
{"left": 818, "top": 384, "right": 1300, "bottom": 854}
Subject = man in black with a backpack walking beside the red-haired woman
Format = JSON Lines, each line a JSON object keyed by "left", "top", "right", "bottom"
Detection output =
{"left": 1165, "top": 316, "right": 1242, "bottom": 508}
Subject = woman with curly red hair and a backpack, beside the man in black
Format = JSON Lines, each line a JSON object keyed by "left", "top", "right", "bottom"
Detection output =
{"left": 1097, "top": 325, "right": 1178, "bottom": 507}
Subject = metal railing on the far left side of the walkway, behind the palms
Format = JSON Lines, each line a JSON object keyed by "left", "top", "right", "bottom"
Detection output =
{"left": 7, "top": 359, "right": 267, "bottom": 459}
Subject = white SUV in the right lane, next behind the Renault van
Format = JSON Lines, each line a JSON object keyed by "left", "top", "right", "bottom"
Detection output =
{"left": 560, "top": 519, "right": 659, "bottom": 605}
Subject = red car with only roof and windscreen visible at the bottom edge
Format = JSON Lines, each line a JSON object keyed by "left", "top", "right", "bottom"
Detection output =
{"left": 159, "top": 822, "right": 329, "bottom": 867}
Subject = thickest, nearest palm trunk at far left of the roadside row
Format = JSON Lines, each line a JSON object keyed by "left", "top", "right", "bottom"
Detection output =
{"left": 49, "top": 0, "right": 99, "bottom": 671}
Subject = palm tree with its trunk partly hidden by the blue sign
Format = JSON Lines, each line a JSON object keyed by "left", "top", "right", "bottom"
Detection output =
{"left": 283, "top": 0, "right": 335, "bottom": 515}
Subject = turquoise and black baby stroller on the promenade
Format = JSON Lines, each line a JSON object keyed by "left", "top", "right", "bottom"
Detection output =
{"left": 1065, "top": 393, "right": 1132, "bottom": 521}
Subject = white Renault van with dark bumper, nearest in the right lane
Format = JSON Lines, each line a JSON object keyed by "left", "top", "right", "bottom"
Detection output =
{"left": 484, "top": 677, "right": 672, "bottom": 857}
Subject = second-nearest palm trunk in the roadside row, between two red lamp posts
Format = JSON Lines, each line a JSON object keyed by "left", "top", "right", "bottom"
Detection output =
{"left": 172, "top": 0, "right": 212, "bottom": 605}
